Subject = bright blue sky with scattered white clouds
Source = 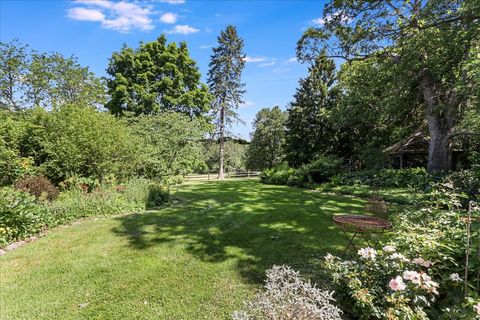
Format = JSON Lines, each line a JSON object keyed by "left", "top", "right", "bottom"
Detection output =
{"left": 0, "top": 0, "right": 324, "bottom": 140}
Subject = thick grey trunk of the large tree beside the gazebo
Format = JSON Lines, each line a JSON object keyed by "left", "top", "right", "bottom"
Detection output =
{"left": 421, "top": 71, "right": 456, "bottom": 173}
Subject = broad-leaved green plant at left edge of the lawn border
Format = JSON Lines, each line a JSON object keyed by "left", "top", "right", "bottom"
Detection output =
{"left": 0, "top": 187, "right": 49, "bottom": 245}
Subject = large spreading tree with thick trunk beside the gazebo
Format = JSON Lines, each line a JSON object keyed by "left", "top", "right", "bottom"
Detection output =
{"left": 297, "top": 0, "right": 480, "bottom": 172}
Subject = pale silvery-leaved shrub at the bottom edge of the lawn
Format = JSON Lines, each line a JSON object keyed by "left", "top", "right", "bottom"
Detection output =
{"left": 232, "top": 266, "right": 342, "bottom": 320}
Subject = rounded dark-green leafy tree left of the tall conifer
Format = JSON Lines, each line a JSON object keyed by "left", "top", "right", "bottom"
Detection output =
{"left": 106, "top": 35, "right": 210, "bottom": 117}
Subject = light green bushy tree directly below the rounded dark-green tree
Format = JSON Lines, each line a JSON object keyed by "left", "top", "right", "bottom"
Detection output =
{"left": 131, "top": 112, "right": 204, "bottom": 180}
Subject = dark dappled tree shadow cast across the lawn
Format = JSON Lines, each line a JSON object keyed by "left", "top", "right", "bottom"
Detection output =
{"left": 113, "top": 180, "right": 364, "bottom": 283}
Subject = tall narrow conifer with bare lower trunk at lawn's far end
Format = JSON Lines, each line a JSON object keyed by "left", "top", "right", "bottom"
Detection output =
{"left": 208, "top": 26, "right": 245, "bottom": 179}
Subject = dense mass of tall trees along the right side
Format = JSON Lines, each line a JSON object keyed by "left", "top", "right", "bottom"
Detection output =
{"left": 246, "top": 1, "right": 480, "bottom": 173}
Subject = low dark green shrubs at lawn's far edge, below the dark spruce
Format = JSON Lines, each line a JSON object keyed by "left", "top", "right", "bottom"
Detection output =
{"left": 260, "top": 155, "right": 343, "bottom": 187}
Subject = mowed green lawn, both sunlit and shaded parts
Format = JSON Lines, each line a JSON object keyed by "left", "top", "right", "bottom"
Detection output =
{"left": 0, "top": 179, "right": 364, "bottom": 319}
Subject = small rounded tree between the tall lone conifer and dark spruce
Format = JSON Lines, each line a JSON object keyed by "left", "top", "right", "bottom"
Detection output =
{"left": 247, "top": 107, "right": 287, "bottom": 170}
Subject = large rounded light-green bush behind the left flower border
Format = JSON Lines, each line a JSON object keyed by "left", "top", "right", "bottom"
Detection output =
{"left": 23, "top": 105, "right": 140, "bottom": 183}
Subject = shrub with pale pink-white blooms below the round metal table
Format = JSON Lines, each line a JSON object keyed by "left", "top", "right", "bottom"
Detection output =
{"left": 325, "top": 245, "right": 446, "bottom": 319}
